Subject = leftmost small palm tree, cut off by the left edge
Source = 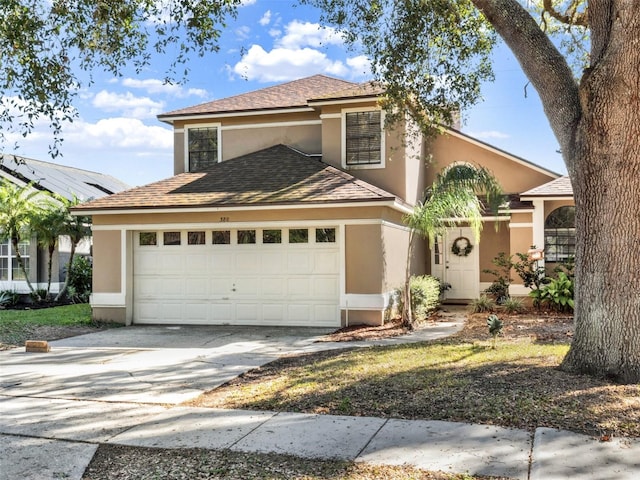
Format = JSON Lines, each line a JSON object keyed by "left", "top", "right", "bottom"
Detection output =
{"left": 0, "top": 178, "right": 43, "bottom": 300}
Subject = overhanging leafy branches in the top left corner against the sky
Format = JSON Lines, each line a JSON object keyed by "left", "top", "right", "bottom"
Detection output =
{"left": 0, "top": 0, "right": 241, "bottom": 156}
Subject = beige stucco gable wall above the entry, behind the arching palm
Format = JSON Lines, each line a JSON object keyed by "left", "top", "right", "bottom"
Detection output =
{"left": 427, "top": 134, "right": 555, "bottom": 193}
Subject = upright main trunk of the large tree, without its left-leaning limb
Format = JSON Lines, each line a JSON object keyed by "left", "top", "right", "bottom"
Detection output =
{"left": 562, "top": 2, "right": 640, "bottom": 383}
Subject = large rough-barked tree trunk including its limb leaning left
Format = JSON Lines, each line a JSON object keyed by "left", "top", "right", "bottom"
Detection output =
{"left": 472, "top": 0, "right": 640, "bottom": 383}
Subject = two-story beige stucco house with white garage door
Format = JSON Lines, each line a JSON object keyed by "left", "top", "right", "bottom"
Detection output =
{"left": 76, "top": 75, "right": 576, "bottom": 326}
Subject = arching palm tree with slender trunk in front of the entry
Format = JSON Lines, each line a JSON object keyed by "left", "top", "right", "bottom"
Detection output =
{"left": 402, "top": 163, "right": 504, "bottom": 328}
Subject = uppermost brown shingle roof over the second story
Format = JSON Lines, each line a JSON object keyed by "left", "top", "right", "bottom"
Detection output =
{"left": 158, "top": 75, "right": 358, "bottom": 121}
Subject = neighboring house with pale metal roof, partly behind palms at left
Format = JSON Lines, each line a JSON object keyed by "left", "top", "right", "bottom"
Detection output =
{"left": 0, "top": 154, "right": 129, "bottom": 293}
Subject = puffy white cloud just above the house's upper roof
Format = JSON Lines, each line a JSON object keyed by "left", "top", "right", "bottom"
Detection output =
{"left": 233, "top": 45, "right": 349, "bottom": 82}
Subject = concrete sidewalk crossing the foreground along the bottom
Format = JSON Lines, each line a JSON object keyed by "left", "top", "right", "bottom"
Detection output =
{"left": 0, "top": 397, "right": 640, "bottom": 480}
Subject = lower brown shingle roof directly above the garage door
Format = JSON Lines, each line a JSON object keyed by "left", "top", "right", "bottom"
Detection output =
{"left": 74, "top": 145, "right": 397, "bottom": 211}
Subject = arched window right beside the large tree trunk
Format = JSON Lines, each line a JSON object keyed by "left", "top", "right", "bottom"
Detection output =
{"left": 544, "top": 206, "right": 576, "bottom": 262}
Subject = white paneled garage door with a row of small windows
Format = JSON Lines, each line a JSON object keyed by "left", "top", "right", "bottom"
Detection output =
{"left": 133, "top": 228, "right": 340, "bottom": 326}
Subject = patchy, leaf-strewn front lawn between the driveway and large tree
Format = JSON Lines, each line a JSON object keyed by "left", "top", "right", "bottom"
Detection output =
{"left": 191, "top": 316, "right": 640, "bottom": 437}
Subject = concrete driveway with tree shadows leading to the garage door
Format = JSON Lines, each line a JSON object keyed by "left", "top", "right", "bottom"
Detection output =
{"left": 0, "top": 326, "right": 331, "bottom": 404}
